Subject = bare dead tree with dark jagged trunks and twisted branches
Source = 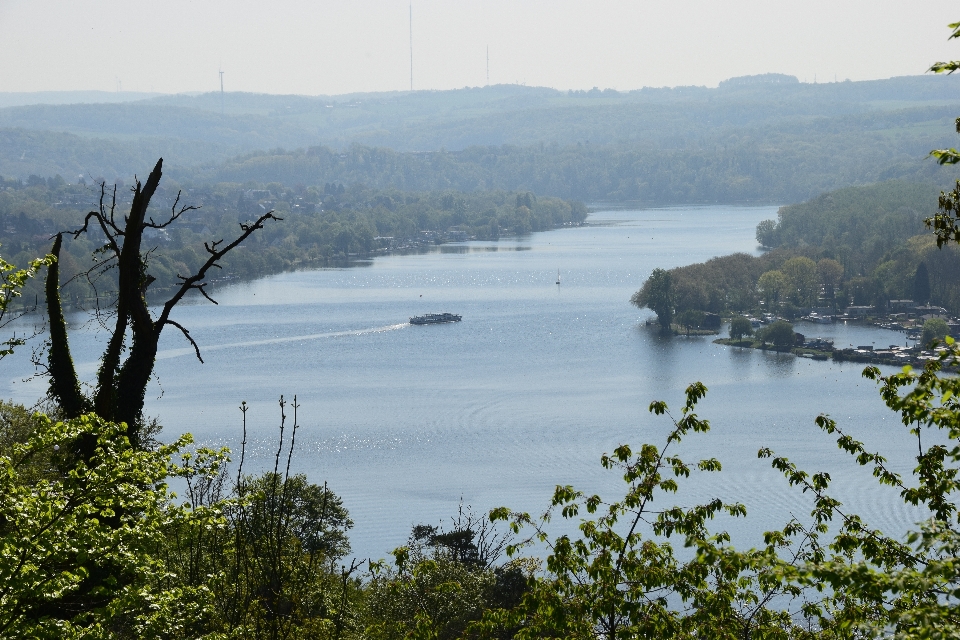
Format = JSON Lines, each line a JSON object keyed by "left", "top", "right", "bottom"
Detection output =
{"left": 46, "top": 158, "right": 280, "bottom": 442}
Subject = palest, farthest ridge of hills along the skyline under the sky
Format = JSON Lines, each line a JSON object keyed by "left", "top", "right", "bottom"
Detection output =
{"left": 0, "top": 76, "right": 960, "bottom": 151}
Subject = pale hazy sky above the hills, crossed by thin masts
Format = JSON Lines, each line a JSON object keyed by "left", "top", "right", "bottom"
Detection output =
{"left": 0, "top": 0, "right": 960, "bottom": 94}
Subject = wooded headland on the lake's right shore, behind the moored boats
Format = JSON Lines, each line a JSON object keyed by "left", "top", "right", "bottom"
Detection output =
{"left": 644, "top": 181, "right": 960, "bottom": 315}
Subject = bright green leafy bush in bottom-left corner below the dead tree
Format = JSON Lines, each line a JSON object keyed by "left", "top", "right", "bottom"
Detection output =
{"left": 0, "top": 415, "right": 227, "bottom": 638}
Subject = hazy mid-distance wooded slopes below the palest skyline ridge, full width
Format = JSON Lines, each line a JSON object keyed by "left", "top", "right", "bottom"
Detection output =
{"left": 0, "top": 107, "right": 950, "bottom": 205}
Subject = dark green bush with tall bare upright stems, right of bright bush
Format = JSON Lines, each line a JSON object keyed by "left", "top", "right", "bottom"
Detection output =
{"left": 185, "top": 398, "right": 361, "bottom": 640}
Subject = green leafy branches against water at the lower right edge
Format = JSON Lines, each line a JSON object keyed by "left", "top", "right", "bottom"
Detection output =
{"left": 759, "top": 338, "right": 960, "bottom": 638}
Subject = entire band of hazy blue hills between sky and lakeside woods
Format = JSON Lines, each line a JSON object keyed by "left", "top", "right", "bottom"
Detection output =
{"left": 0, "top": 74, "right": 960, "bottom": 204}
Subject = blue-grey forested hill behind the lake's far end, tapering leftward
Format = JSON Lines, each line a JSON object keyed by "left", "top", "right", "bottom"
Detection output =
{"left": 184, "top": 116, "right": 953, "bottom": 205}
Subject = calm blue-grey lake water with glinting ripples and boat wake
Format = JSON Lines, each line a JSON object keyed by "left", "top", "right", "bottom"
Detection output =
{"left": 0, "top": 207, "right": 923, "bottom": 558}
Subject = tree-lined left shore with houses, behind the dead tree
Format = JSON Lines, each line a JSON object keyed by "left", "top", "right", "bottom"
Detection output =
{"left": 0, "top": 176, "right": 587, "bottom": 304}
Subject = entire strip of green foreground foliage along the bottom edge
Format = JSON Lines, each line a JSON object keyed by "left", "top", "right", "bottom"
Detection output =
{"left": 9, "top": 350, "right": 960, "bottom": 639}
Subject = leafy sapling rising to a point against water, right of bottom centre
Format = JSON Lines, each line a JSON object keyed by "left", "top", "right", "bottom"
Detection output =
{"left": 474, "top": 383, "right": 805, "bottom": 639}
